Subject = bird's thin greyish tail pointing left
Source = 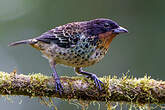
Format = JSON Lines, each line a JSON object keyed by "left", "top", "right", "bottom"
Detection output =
{"left": 8, "top": 39, "right": 37, "bottom": 46}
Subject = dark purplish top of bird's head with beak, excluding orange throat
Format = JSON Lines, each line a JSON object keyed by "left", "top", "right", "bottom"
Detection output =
{"left": 86, "top": 18, "right": 128, "bottom": 36}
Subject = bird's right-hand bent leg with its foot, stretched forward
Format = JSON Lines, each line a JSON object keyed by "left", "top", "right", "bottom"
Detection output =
{"left": 75, "top": 67, "right": 104, "bottom": 90}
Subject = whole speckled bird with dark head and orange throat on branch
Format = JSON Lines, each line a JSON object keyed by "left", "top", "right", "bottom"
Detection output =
{"left": 9, "top": 18, "right": 128, "bottom": 94}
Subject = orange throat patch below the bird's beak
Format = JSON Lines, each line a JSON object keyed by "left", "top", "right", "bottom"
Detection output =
{"left": 99, "top": 32, "right": 117, "bottom": 49}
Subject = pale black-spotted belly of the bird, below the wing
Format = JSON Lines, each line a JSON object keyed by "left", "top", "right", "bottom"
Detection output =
{"left": 41, "top": 43, "right": 105, "bottom": 67}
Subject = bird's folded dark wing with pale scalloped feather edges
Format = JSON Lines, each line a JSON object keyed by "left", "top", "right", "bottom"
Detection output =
{"left": 36, "top": 24, "right": 82, "bottom": 48}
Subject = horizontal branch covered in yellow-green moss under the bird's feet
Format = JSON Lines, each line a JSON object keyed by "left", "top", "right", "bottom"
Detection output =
{"left": 0, "top": 72, "right": 165, "bottom": 104}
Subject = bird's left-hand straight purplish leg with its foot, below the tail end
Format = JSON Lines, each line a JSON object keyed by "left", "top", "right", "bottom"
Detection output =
{"left": 50, "top": 61, "right": 63, "bottom": 95}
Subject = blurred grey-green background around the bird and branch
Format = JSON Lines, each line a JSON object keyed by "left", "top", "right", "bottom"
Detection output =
{"left": 0, "top": 0, "right": 165, "bottom": 110}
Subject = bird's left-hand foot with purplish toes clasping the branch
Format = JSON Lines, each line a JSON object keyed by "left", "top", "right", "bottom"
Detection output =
{"left": 55, "top": 78, "right": 63, "bottom": 95}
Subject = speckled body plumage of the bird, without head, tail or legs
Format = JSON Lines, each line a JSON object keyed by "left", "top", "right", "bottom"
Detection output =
{"left": 33, "top": 19, "right": 117, "bottom": 67}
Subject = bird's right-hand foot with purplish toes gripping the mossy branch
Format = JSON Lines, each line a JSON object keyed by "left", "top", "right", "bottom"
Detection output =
{"left": 87, "top": 74, "right": 104, "bottom": 91}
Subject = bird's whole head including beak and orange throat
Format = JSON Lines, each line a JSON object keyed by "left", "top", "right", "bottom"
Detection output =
{"left": 83, "top": 18, "right": 128, "bottom": 49}
